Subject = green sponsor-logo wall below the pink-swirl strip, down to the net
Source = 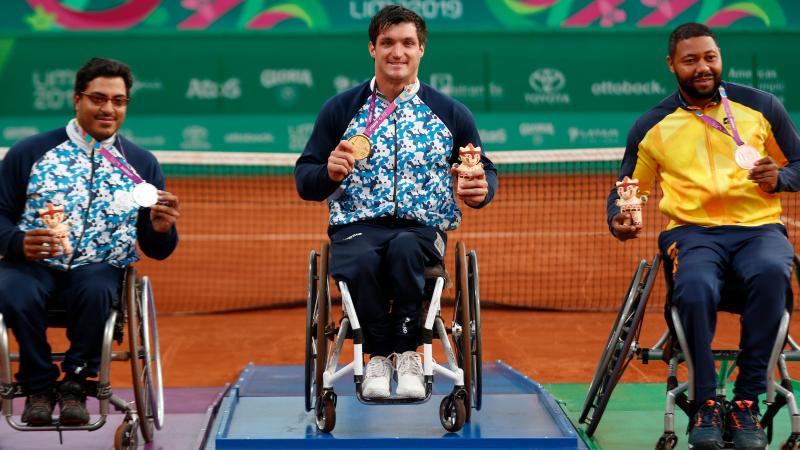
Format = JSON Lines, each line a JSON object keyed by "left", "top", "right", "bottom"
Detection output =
{"left": 0, "top": 30, "right": 800, "bottom": 152}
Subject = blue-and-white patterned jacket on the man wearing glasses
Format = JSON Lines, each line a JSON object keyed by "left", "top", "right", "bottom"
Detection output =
{"left": 0, "top": 121, "right": 178, "bottom": 270}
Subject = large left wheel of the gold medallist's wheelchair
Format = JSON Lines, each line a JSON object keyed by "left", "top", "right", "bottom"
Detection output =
{"left": 312, "top": 242, "right": 333, "bottom": 416}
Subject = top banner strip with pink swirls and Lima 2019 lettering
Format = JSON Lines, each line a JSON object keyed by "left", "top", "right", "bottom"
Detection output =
{"left": 0, "top": 0, "right": 800, "bottom": 34}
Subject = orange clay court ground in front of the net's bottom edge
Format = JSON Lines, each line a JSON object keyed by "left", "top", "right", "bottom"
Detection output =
{"left": 18, "top": 308, "right": 800, "bottom": 387}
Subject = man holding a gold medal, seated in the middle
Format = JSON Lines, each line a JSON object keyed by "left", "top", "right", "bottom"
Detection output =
{"left": 295, "top": 6, "right": 497, "bottom": 398}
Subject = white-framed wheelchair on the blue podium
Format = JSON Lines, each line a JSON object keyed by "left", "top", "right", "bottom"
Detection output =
{"left": 305, "top": 242, "right": 482, "bottom": 433}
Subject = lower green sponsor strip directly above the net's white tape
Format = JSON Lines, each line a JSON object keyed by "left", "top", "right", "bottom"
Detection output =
{"left": 0, "top": 113, "right": 636, "bottom": 154}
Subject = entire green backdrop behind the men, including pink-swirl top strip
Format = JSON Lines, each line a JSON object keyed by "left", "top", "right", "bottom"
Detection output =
{"left": 0, "top": 0, "right": 800, "bottom": 152}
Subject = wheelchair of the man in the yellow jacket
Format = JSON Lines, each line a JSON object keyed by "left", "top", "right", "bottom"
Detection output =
{"left": 578, "top": 255, "right": 800, "bottom": 450}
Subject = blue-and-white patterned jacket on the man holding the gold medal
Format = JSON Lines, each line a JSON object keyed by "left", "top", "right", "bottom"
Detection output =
{"left": 295, "top": 79, "right": 497, "bottom": 231}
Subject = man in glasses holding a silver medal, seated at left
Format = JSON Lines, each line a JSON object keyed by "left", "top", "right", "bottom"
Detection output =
{"left": 0, "top": 58, "right": 179, "bottom": 426}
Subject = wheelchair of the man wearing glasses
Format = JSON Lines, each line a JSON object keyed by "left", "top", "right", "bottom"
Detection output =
{"left": 0, "top": 267, "right": 164, "bottom": 450}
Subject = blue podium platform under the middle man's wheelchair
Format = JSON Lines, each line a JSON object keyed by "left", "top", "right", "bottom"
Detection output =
{"left": 206, "top": 361, "right": 587, "bottom": 450}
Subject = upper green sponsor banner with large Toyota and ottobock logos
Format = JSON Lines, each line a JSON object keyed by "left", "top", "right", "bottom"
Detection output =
{"left": 0, "top": 32, "right": 800, "bottom": 117}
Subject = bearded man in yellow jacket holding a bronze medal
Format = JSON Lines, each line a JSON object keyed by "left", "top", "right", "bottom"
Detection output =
{"left": 608, "top": 23, "right": 800, "bottom": 449}
